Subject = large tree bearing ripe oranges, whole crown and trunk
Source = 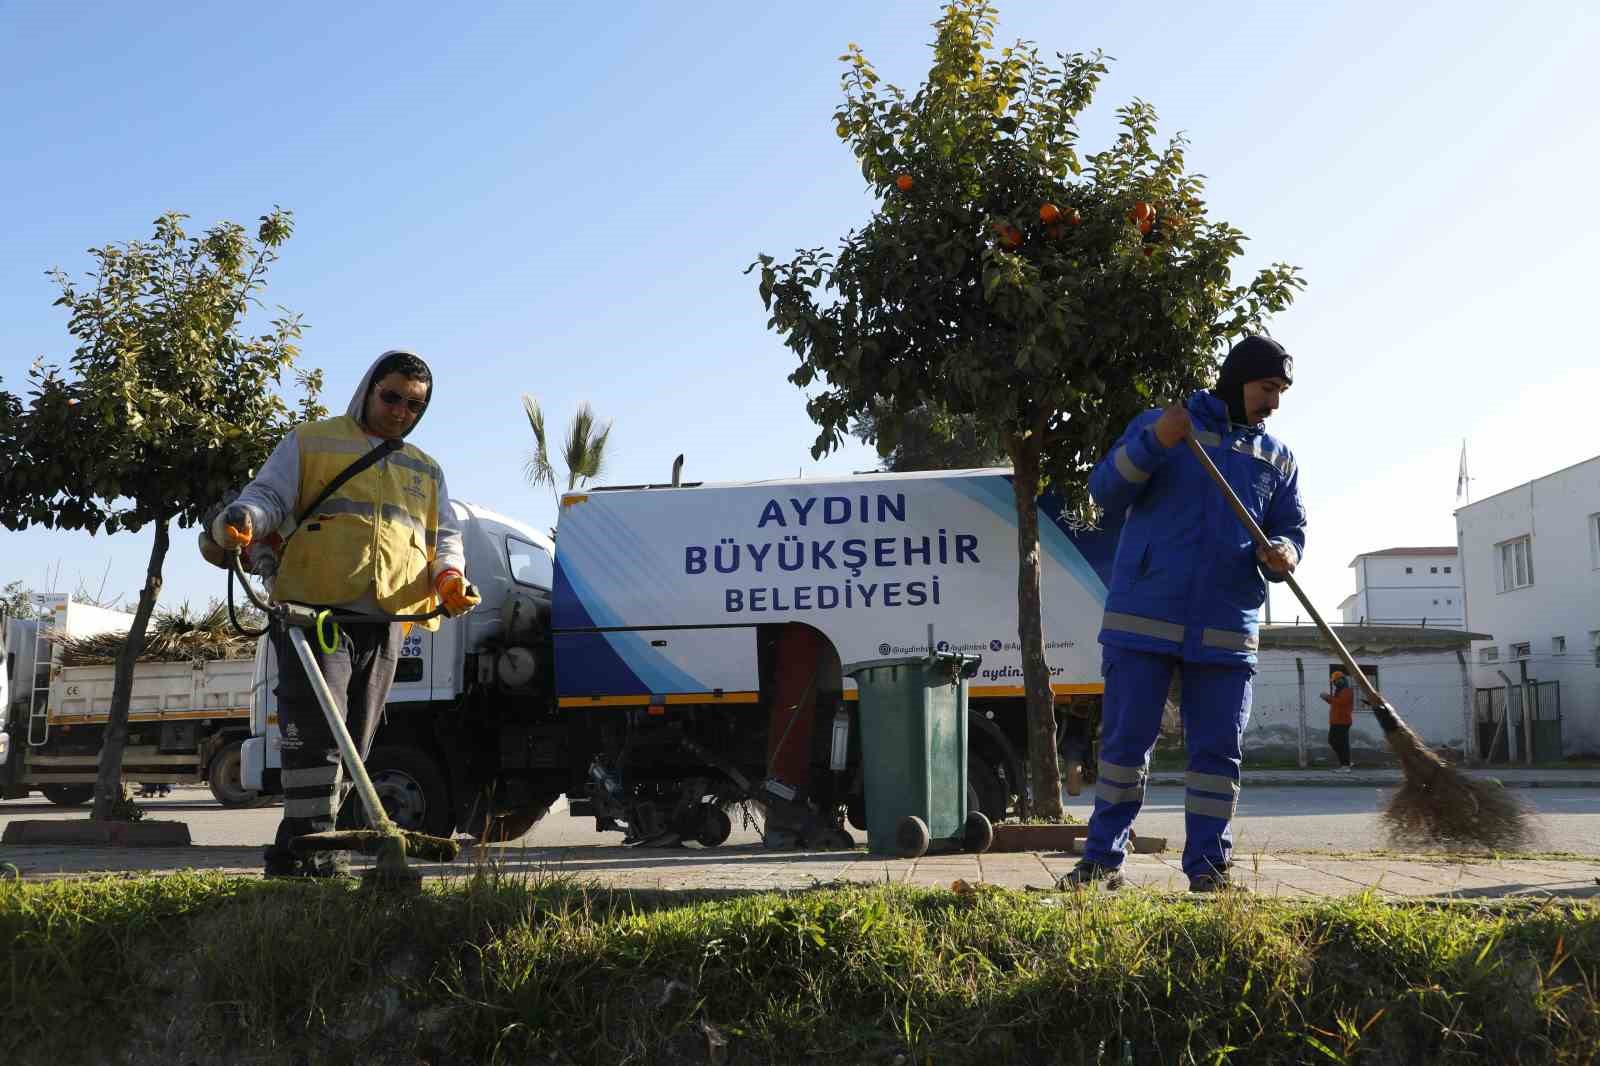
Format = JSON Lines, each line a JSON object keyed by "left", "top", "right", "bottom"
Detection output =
{"left": 750, "top": 0, "right": 1302, "bottom": 816}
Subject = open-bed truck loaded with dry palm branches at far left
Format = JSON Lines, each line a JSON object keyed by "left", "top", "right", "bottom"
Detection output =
{"left": 0, "top": 597, "right": 262, "bottom": 807}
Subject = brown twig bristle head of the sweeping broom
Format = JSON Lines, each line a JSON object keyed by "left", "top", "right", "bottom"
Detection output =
{"left": 1384, "top": 719, "right": 1533, "bottom": 852}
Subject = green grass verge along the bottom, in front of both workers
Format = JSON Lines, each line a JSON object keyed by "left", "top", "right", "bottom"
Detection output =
{"left": 0, "top": 871, "right": 1600, "bottom": 1066}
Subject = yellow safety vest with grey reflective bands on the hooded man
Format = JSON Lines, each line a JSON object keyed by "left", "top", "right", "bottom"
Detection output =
{"left": 272, "top": 415, "right": 443, "bottom": 629}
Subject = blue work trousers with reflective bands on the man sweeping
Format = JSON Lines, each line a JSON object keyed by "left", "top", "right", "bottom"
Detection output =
{"left": 1083, "top": 645, "right": 1256, "bottom": 877}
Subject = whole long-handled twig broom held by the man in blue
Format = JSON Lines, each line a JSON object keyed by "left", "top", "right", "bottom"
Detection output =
{"left": 1186, "top": 434, "right": 1531, "bottom": 852}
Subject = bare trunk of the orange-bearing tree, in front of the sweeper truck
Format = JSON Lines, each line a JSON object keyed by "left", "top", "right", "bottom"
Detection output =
{"left": 1011, "top": 434, "right": 1062, "bottom": 820}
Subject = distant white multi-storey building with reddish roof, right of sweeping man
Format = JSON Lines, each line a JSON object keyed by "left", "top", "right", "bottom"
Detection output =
{"left": 1339, "top": 547, "right": 1467, "bottom": 629}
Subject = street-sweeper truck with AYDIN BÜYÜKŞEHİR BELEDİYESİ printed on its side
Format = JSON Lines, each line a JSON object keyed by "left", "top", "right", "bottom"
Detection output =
{"left": 243, "top": 469, "right": 1115, "bottom": 845}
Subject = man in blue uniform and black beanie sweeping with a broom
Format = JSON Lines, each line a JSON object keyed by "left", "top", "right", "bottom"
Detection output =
{"left": 1059, "top": 336, "right": 1306, "bottom": 892}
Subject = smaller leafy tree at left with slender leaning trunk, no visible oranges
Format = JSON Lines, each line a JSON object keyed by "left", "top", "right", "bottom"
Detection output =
{"left": 0, "top": 210, "right": 326, "bottom": 818}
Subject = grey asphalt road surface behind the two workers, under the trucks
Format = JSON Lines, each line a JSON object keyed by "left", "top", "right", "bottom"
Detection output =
{"left": 12, "top": 784, "right": 1600, "bottom": 856}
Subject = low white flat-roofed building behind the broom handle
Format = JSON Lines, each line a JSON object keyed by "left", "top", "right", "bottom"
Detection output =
{"left": 1245, "top": 623, "right": 1488, "bottom": 767}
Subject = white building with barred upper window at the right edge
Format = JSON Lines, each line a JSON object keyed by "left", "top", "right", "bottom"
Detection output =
{"left": 1456, "top": 456, "right": 1600, "bottom": 762}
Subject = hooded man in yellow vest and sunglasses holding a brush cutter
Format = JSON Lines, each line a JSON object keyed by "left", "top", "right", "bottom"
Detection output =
{"left": 211, "top": 351, "right": 478, "bottom": 877}
